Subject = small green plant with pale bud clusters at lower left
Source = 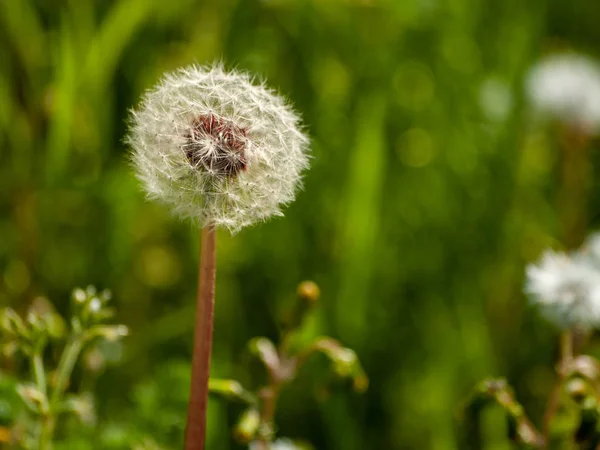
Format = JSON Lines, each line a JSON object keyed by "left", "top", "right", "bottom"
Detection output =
{"left": 0, "top": 286, "right": 128, "bottom": 450}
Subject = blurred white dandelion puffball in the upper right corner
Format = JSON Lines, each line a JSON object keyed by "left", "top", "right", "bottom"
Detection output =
{"left": 526, "top": 53, "right": 600, "bottom": 135}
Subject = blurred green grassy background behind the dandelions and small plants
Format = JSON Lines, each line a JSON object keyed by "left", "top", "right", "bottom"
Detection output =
{"left": 0, "top": 0, "right": 600, "bottom": 450}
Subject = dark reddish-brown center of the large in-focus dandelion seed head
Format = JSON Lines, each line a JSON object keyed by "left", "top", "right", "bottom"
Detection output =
{"left": 183, "top": 114, "right": 247, "bottom": 177}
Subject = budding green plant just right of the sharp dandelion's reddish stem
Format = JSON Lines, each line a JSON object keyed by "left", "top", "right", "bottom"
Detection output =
{"left": 209, "top": 281, "right": 369, "bottom": 450}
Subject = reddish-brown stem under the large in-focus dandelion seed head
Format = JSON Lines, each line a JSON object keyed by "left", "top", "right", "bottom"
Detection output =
{"left": 185, "top": 226, "right": 216, "bottom": 450}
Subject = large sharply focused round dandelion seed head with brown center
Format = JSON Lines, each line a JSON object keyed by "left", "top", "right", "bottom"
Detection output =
{"left": 126, "top": 65, "right": 309, "bottom": 232}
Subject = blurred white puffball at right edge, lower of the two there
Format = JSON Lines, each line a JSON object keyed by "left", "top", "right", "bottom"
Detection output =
{"left": 525, "top": 250, "right": 600, "bottom": 328}
